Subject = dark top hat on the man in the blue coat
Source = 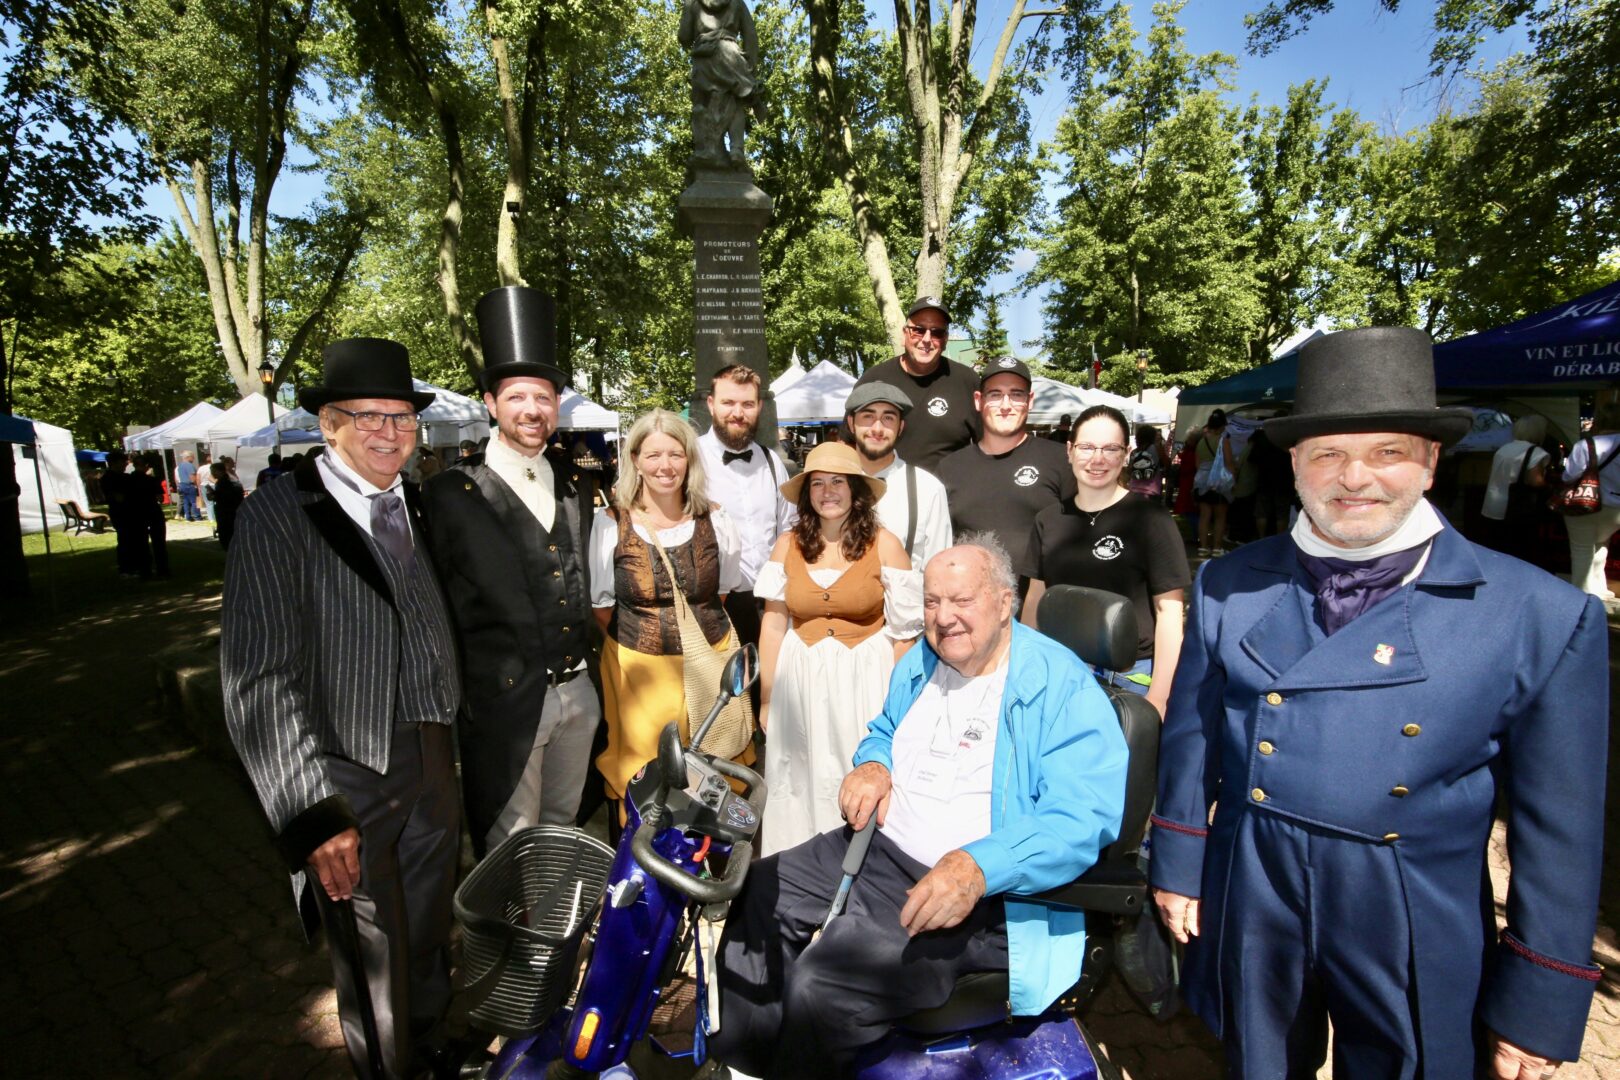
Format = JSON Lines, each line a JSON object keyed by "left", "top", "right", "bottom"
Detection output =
{"left": 1265, "top": 325, "right": 1474, "bottom": 447}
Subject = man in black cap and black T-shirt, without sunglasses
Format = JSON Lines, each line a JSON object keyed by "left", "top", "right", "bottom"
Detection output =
{"left": 936, "top": 356, "right": 1076, "bottom": 594}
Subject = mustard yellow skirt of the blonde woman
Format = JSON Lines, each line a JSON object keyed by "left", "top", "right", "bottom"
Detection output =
{"left": 596, "top": 633, "right": 753, "bottom": 800}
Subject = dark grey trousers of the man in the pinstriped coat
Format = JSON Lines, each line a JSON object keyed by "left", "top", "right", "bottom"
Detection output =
{"left": 313, "top": 724, "right": 462, "bottom": 1080}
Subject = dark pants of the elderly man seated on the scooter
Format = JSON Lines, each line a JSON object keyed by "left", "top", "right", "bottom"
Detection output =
{"left": 711, "top": 827, "right": 1008, "bottom": 1080}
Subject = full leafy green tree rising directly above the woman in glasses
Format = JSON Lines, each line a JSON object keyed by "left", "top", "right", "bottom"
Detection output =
{"left": 1025, "top": 3, "right": 1262, "bottom": 392}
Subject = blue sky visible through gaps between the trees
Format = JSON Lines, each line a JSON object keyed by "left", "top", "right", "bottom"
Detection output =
{"left": 147, "top": 0, "right": 1524, "bottom": 361}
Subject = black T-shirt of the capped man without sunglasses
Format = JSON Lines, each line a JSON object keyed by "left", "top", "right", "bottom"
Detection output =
{"left": 939, "top": 436, "right": 1076, "bottom": 576}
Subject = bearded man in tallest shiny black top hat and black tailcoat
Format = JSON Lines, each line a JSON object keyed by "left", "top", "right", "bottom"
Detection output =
{"left": 424, "top": 285, "right": 601, "bottom": 855}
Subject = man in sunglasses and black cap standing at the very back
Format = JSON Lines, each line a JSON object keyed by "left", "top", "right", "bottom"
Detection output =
{"left": 857, "top": 296, "right": 978, "bottom": 471}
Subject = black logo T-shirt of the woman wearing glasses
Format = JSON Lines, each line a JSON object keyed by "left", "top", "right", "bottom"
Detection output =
{"left": 1029, "top": 494, "right": 1192, "bottom": 659}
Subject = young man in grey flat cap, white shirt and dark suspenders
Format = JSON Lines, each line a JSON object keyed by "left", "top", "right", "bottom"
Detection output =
{"left": 844, "top": 382, "right": 951, "bottom": 567}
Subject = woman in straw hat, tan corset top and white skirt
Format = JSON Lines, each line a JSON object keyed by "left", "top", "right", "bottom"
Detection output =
{"left": 753, "top": 442, "right": 922, "bottom": 855}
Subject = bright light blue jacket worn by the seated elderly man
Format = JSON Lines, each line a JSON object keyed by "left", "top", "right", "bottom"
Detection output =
{"left": 855, "top": 623, "right": 1126, "bottom": 1015}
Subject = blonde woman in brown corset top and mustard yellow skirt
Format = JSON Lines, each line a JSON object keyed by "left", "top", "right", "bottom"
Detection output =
{"left": 590, "top": 410, "right": 753, "bottom": 816}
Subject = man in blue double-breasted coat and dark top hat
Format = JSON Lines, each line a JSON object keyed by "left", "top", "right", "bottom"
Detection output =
{"left": 1150, "top": 327, "right": 1609, "bottom": 1080}
